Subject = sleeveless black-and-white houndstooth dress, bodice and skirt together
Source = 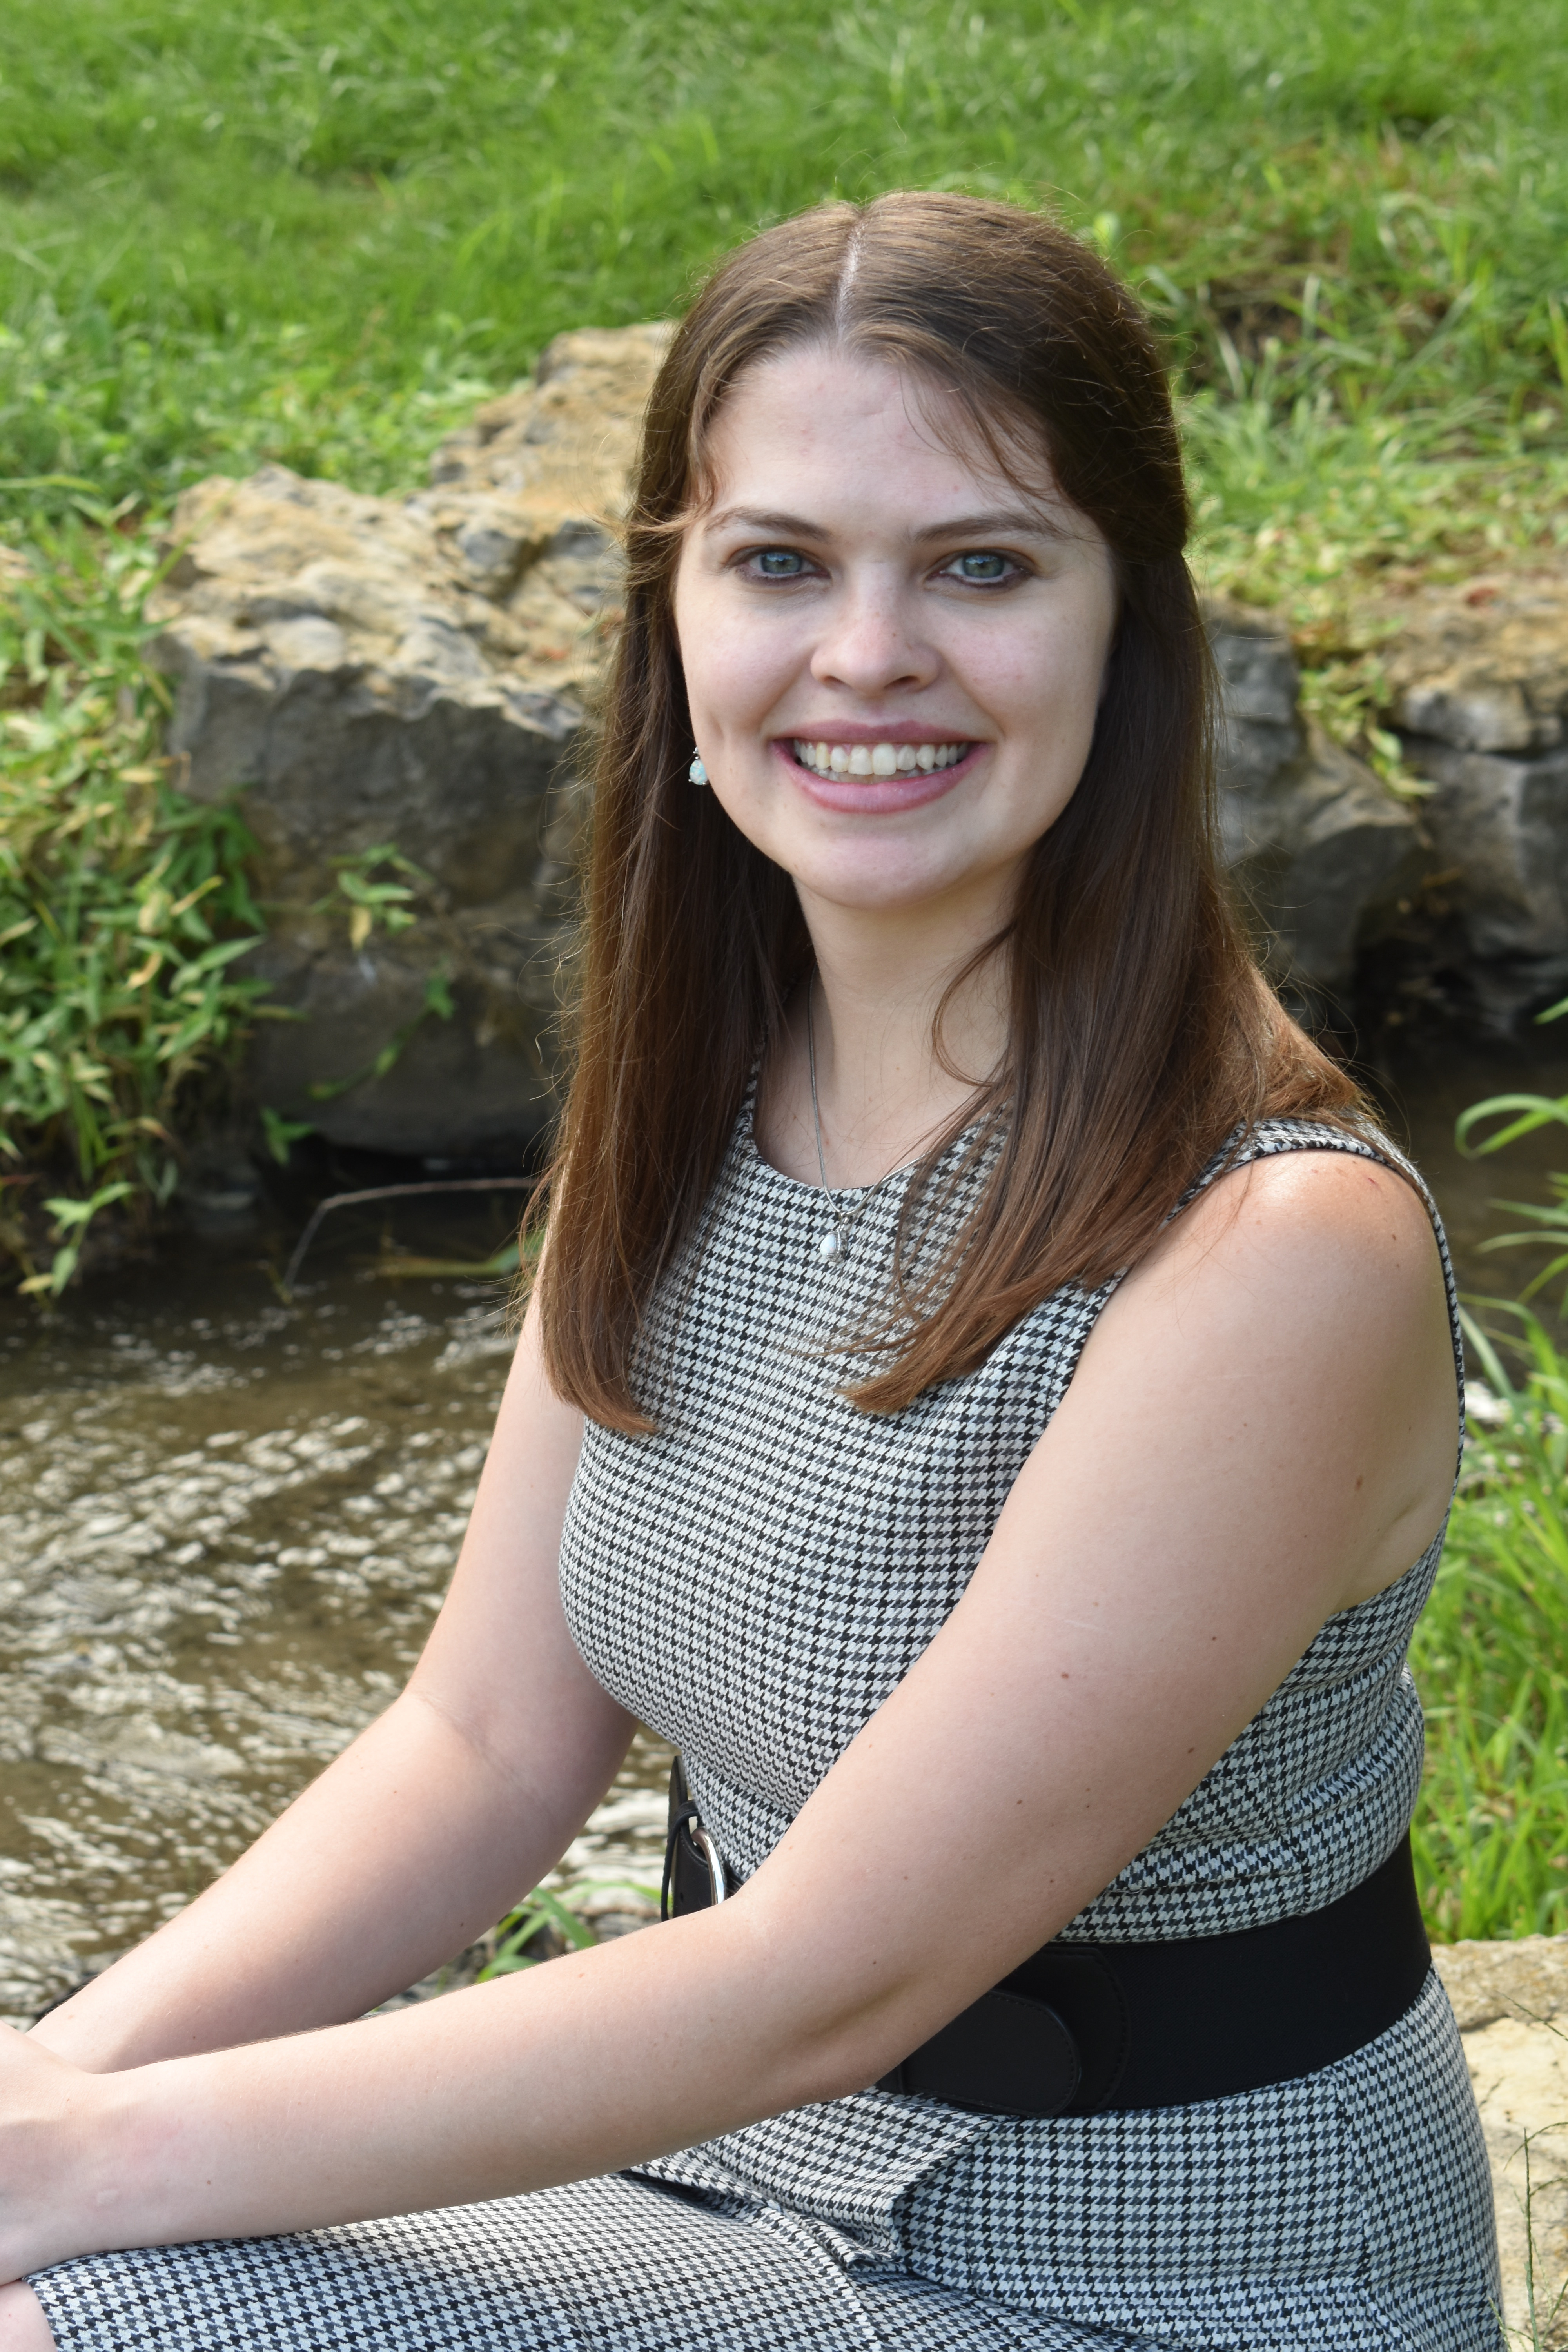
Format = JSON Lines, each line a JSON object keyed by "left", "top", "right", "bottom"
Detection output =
{"left": 33, "top": 1103, "right": 1502, "bottom": 2352}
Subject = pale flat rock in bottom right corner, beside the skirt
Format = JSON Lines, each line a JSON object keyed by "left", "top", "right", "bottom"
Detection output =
{"left": 1432, "top": 1936, "right": 1568, "bottom": 2352}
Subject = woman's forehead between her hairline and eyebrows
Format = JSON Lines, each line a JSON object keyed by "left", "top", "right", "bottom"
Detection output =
{"left": 701, "top": 343, "right": 1065, "bottom": 517}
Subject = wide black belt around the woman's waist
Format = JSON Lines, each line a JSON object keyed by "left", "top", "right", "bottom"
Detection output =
{"left": 661, "top": 1757, "right": 1432, "bottom": 2114}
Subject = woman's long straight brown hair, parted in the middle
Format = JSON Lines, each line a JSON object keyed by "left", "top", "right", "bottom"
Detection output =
{"left": 541, "top": 195, "right": 1363, "bottom": 1432}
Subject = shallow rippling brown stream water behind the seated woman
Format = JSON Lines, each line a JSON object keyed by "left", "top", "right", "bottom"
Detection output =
{"left": 0, "top": 1054, "right": 1568, "bottom": 2016}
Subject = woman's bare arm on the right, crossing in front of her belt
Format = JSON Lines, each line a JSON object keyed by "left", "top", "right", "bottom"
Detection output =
{"left": 0, "top": 1152, "right": 1455, "bottom": 2277}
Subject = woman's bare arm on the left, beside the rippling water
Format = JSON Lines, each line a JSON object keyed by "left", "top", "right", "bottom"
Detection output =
{"left": 23, "top": 1322, "right": 632, "bottom": 2072}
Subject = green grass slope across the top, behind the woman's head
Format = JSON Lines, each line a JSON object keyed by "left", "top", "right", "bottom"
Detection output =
{"left": 0, "top": 0, "right": 1568, "bottom": 546}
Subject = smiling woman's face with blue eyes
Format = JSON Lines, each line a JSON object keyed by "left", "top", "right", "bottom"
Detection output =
{"left": 675, "top": 348, "right": 1117, "bottom": 920}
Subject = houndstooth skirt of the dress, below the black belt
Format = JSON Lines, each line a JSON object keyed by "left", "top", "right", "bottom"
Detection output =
{"left": 31, "top": 1976, "right": 1502, "bottom": 2352}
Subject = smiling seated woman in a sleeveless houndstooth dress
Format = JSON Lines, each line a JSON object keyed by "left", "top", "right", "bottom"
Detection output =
{"left": 0, "top": 195, "right": 1497, "bottom": 2352}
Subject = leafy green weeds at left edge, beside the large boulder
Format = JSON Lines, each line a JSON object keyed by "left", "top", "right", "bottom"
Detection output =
{"left": 0, "top": 513, "right": 261, "bottom": 1294}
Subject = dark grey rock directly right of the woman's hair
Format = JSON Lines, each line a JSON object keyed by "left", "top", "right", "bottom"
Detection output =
{"left": 1208, "top": 604, "right": 1427, "bottom": 1002}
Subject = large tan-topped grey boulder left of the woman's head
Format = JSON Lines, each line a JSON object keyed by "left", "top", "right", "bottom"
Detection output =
{"left": 153, "top": 327, "right": 670, "bottom": 1157}
